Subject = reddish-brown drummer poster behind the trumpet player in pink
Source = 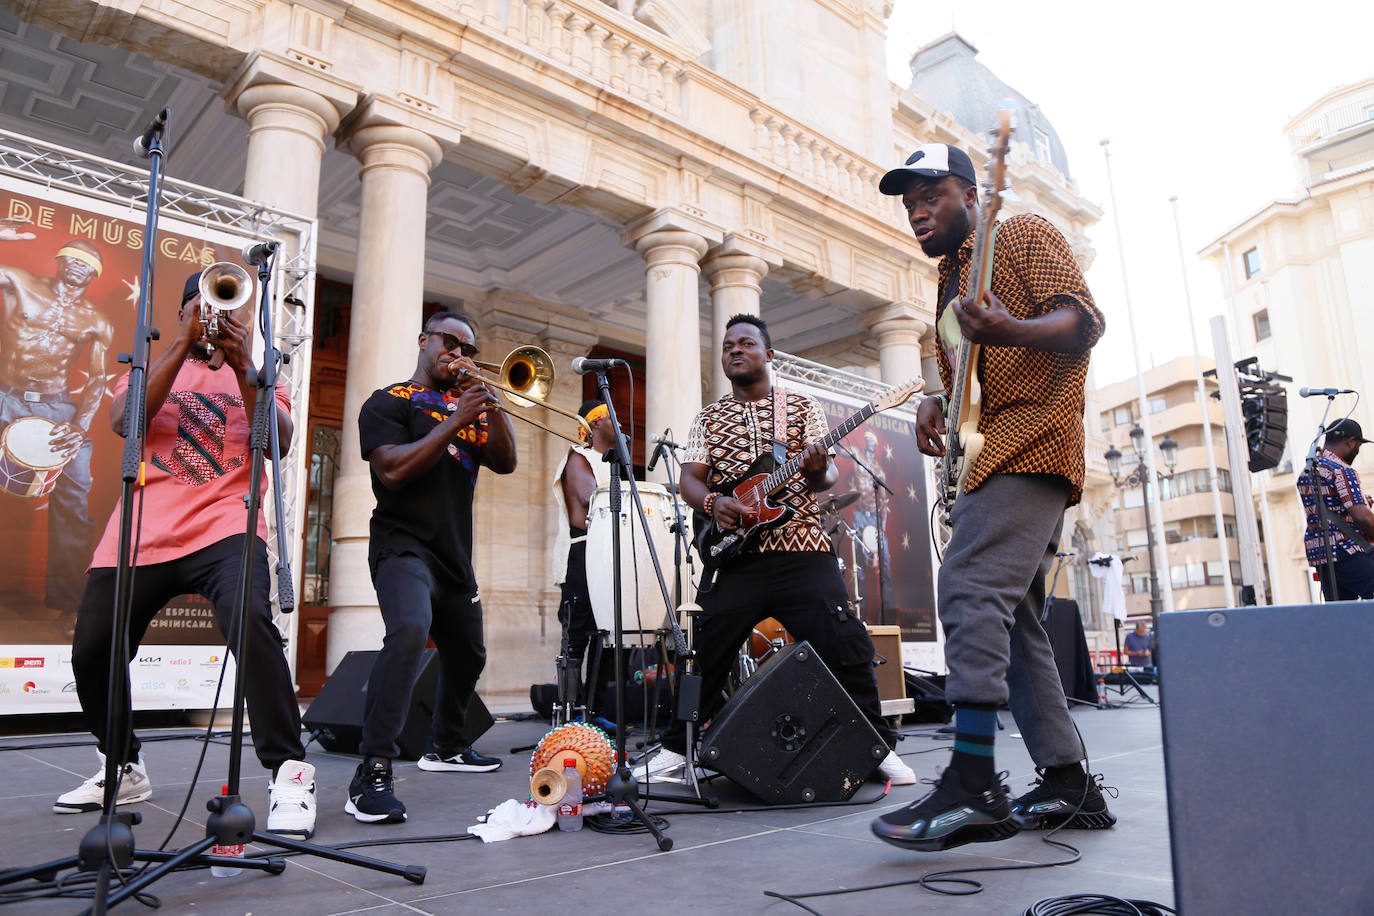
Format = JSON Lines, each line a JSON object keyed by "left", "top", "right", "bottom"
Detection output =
{"left": 0, "top": 176, "right": 239, "bottom": 715}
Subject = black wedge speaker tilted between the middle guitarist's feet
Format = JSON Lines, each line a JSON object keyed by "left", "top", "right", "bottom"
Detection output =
{"left": 701, "top": 643, "right": 888, "bottom": 805}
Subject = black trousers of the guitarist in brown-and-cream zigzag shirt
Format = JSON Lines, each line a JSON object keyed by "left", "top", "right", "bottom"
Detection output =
{"left": 664, "top": 551, "right": 897, "bottom": 754}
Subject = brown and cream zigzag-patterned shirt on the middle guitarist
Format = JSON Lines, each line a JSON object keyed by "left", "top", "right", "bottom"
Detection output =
{"left": 683, "top": 391, "right": 830, "bottom": 552}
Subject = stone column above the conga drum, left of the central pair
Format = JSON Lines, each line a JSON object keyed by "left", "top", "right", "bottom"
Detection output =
{"left": 635, "top": 229, "right": 708, "bottom": 479}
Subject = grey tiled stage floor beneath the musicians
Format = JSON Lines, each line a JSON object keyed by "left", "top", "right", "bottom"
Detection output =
{"left": 0, "top": 691, "right": 1173, "bottom": 916}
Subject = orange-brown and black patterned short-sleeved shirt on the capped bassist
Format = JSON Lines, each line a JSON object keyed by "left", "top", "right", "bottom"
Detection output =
{"left": 936, "top": 213, "right": 1106, "bottom": 505}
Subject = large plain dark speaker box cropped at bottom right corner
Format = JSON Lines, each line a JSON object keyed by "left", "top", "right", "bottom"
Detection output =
{"left": 1158, "top": 602, "right": 1374, "bottom": 916}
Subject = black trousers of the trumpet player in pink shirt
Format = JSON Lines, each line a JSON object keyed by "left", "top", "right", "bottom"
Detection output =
{"left": 71, "top": 534, "right": 305, "bottom": 772}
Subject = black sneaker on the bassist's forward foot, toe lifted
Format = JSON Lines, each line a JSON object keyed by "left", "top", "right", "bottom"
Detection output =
{"left": 871, "top": 769, "right": 1017, "bottom": 853}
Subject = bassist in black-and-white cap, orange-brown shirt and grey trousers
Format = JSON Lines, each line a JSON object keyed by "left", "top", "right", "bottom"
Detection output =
{"left": 872, "top": 143, "right": 1116, "bottom": 851}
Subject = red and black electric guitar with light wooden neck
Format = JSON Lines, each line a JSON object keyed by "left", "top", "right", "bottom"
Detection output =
{"left": 692, "top": 378, "right": 925, "bottom": 582}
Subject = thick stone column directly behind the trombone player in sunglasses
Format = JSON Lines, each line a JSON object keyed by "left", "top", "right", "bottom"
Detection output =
{"left": 326, "top": 125, "right": 442, "bottom": 670}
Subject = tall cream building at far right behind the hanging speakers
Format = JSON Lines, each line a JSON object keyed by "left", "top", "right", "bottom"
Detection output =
{"left": 1202, "top": 78, "right": 1374, "bottom": 604}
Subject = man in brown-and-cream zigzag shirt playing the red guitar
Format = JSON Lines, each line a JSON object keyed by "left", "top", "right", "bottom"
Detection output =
{"left": 635, "top": 314, "right": 916, "bottom": 786}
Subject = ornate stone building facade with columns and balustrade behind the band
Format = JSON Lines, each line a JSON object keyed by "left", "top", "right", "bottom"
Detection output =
{"left": 0, "top": 0, "right": 1105, "bottom": 694}
